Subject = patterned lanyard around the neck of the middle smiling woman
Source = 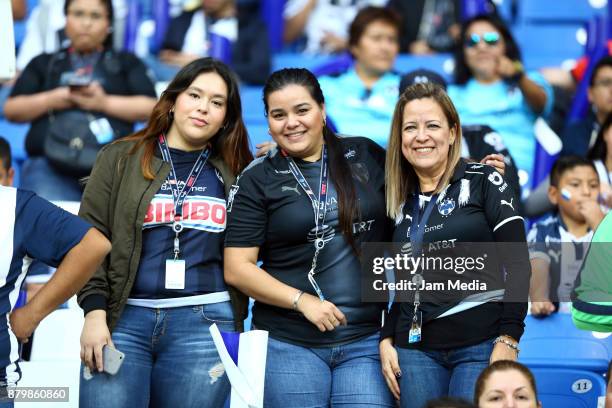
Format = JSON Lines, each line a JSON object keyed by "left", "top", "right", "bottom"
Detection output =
{"left": 281, "top": 145, "right": 328, "bottom": 301}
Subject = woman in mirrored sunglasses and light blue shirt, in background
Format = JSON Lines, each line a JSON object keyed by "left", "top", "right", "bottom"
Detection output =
{"left": 448, "top": 15, "right": 553, "bottom": 200}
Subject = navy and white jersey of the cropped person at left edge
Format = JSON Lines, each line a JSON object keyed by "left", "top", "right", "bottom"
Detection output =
{"left": 0, "top": 186, "right": 90, "bottom": 384}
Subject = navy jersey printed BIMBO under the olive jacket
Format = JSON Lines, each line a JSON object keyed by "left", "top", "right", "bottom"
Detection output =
{"left": 130, "top": 149, "right": 226, "bottom": 299}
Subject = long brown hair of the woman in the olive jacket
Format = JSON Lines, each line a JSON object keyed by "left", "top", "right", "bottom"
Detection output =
{"left": 119, "top": 58, "right": 253, "bottom": 180}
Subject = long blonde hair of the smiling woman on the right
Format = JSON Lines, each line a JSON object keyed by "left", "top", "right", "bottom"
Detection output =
{"left": 385, "top": 83, "right": 462, "bottom": 218}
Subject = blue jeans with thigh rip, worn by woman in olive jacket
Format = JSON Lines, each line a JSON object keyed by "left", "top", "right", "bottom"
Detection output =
{"left": 79, "top": 302, "right": 234, "bottom": 408}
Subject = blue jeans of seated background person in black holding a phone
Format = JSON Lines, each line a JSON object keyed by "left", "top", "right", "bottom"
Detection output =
{"left": 19, "top": 156, "right": 82, "bottom": 201}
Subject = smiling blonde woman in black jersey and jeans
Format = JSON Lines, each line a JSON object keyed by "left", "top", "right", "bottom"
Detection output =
{"left": 380, "top": 83, "right": 530, "bottom": 407}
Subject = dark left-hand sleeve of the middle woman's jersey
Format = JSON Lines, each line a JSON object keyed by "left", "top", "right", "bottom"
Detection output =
{"left": 225, "top": 164, "right": 267, "bottom": 248}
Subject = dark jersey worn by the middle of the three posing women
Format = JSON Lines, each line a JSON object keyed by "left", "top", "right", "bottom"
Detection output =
{"left": 225, "top": 137, "right": 390, "bottom": 347}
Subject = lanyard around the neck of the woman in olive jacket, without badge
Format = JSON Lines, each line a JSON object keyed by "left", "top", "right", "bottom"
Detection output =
{"left": 157, "top": 134, "right": 210, "bottom": 259}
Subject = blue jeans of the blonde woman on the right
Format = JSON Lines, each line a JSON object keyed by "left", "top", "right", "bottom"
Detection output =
{"left": 396, "top": 339, "right": 493, "bottom": 408}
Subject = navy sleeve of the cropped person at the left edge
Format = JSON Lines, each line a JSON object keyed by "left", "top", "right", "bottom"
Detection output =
{"left": 16, "top": 192, "right": 91, "bottom": 267}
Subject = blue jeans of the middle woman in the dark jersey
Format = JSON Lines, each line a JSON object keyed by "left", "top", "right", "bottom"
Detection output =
{"left": 264, "top": 333, "right": 395, "bottom": 408}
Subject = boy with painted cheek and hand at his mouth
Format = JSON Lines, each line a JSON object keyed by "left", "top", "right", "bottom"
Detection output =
{"left": 527, "top": 156, "right": 604, "bottom": 316}
